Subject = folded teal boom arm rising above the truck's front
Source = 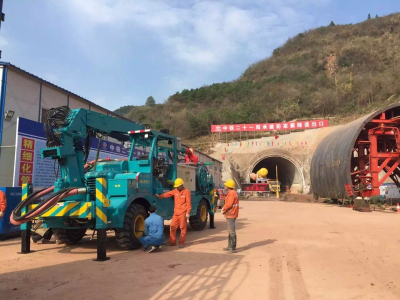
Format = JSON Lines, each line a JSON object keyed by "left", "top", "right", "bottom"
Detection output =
{"left": 42, "top": 106, "right": 144, "bottom": 189}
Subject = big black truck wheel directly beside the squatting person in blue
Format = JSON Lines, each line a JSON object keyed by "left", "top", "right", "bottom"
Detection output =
{"left": 115, "top": 204, "right": 147, "bottom": 250}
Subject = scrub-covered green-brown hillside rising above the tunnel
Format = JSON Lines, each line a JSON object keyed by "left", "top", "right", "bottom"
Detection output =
{"left": 116, "top": 14, "right": 400, "bottom": 144}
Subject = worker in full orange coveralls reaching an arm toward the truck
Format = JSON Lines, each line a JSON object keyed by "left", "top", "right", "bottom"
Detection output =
{"left": 156, "top": 178, "right": 192, "bottom": 248}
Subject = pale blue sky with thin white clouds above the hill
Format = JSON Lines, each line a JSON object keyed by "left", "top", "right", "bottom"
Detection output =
{"left": 0, "top": 0, "right": 400, "bottom": 110}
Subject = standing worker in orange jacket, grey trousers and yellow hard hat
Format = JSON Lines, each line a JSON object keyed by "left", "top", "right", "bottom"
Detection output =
{"left": 222, "top": 179, "right": 239, "bottom": 253}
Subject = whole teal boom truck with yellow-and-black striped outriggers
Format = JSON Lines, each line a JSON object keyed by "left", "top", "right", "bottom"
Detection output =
{"left": 11, "top": 107, "right": 214, "bottom": 260}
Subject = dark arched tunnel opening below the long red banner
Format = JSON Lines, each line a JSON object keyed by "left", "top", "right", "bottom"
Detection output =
{"left": 250, "top": 156, "right": 303, "bottom": 192}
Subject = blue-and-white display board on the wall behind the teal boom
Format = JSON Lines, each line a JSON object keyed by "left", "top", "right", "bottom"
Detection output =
{"left": 13, "top": 118, "right": 144, "bottom": 187}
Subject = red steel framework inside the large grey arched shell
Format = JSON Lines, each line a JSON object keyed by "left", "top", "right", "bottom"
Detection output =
{"left": 351, "top": 110, "right": 400, "bottom": 197}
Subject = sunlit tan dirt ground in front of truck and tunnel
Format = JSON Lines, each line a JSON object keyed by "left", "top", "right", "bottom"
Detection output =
{"left": 0, "top": 201, "right": 400, "bottom": 300}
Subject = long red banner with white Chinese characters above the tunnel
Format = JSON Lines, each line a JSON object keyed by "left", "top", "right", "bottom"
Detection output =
{"left": 211, "top": 120, "right": 328, "bottom": 132}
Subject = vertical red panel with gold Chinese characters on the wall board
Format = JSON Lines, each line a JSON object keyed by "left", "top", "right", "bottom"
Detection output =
{"left": 18, "top": 138, "right": 35, "bottom": 186}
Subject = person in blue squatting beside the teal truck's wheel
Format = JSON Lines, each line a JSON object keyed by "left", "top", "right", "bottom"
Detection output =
{"left": 139, "top": 206, "right": 165, "bottom": 253}
